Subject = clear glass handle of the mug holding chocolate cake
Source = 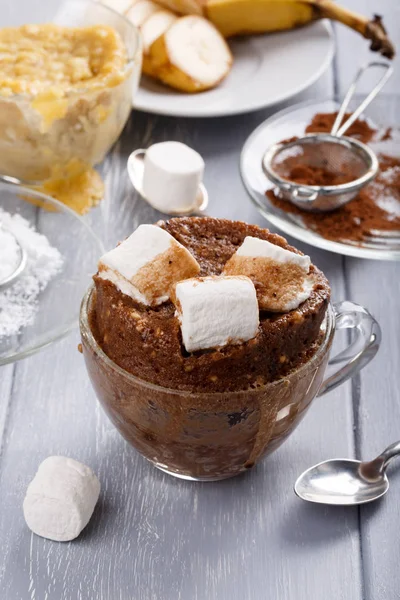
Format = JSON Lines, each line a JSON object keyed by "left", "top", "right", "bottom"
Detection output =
{"left": 318, "top": 300, "right": 382, "bottom": 396}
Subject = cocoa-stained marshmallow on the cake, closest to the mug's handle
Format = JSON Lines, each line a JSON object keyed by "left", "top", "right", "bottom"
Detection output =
{"left": 224, "top": 236, "right": 314, "bottom": 312}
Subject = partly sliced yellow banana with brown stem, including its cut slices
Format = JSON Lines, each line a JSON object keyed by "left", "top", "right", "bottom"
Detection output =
{"left": 101, "top": 0, "right": 395, "bottom": 92}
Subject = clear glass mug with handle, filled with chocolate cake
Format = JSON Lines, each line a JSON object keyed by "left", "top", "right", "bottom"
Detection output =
{"left": 80, "top": 286, "right": 381, "bottom": 481}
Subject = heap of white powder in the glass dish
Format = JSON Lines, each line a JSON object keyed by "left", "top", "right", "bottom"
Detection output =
{"left": 0, "top": 208, "right": 63, "bottom": 337}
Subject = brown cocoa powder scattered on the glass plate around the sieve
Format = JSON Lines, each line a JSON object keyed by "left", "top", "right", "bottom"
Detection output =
{"left": 266, "top": 113, "right": 400, "bottom": 243}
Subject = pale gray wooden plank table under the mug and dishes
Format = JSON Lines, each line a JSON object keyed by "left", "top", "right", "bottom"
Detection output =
{"left": 0, "top": 0, "right": 400, "bottom": 600}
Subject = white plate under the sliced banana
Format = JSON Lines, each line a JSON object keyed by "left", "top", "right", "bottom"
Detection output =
{"left": 134, "top": 21, "right": 335, "bottom": 117}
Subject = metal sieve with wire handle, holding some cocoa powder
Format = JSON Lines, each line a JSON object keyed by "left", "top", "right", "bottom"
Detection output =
{"left": 262, "top": 62, "right": 393, "bottom": 211}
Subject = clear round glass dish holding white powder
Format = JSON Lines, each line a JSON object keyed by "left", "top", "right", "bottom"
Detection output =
{"left": 0, "top": 182, "right": 104, "bottom": 365}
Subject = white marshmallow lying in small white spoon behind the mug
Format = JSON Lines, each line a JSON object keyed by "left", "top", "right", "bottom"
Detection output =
{"left": 143, "top": 142, "right": 204, "bottom": 213}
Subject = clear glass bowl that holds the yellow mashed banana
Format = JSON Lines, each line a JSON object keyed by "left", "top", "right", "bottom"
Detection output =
{"left": 0, "top": 0, "right": 142, "bottom": 184}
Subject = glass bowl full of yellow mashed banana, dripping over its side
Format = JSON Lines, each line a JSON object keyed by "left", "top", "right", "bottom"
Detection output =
{"left": 0, "top": 0, "right": 141, "bottom": 213}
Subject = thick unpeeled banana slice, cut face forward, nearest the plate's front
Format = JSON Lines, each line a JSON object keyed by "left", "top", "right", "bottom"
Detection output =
{"left": 149, "top": 16, "right": 233, "bottom": 92}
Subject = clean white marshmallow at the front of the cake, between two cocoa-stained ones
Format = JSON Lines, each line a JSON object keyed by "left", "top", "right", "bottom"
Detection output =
{"left": 174, "top": 277, "right": 259, "bottom": 352}
